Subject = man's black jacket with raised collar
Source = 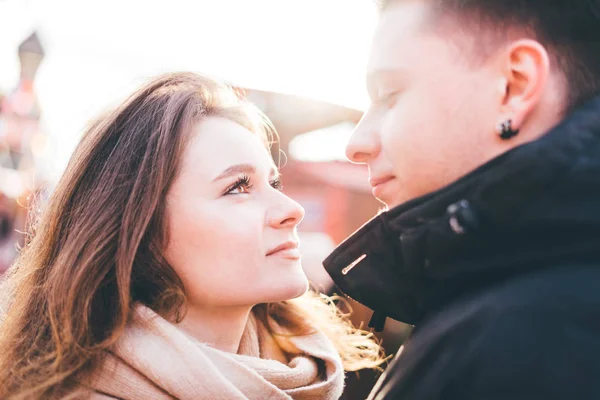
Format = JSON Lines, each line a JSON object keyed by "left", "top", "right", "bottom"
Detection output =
{"left": 324, "top": 98, "right": 600, "bottom": 400}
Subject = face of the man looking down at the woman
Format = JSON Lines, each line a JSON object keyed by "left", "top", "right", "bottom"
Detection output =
{"left": 346, "top": 0, "right": 502, "bottom": 208}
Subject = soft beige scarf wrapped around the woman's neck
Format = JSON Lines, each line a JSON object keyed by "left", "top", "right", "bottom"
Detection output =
{"left": 89, "top": 306, "right": 344, "bottom": 400}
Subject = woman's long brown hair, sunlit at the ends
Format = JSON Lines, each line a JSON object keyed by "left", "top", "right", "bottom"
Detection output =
{"left": 0, "top": 73, "right": 381, "bottom": 399}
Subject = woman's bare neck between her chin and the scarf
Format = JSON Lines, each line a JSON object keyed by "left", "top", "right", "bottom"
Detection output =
{"left": 177, "top": 304, "right": 252, "bottom": 353}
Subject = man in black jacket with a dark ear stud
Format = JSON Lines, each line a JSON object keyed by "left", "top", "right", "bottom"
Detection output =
{"left": 325, "top": 0, "right": 600, "bottom": 400}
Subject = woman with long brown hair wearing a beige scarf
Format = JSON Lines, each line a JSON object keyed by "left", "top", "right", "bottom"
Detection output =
{"left": 0, "top": 74, "right": 382, "bottom": 399}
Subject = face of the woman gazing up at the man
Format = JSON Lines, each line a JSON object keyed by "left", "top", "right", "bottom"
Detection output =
{"left": 165, "top": 117, "right": 308, "bottom": 307}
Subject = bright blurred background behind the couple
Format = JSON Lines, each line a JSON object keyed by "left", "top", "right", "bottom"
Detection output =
{"left": 0, "top": 0, "right": 409, "bottom": 399}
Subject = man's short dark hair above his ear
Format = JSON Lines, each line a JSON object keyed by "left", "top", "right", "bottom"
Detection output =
{"left": 378, "top": 0, "right": 600, "bottom": 111}
